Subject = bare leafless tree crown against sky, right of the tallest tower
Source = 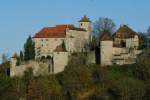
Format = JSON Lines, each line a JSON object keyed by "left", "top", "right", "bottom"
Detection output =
{"left": 93, "top": 18, "right": 116, "bottom": 37}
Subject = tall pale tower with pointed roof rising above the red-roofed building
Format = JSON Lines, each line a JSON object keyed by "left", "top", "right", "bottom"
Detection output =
{"left": 79, "top": 15, "right": 92, "bottom": 41}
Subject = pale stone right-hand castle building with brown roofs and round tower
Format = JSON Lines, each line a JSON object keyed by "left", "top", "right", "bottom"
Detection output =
{"left": 100, "top": 25, "right": 142, "bottom": 66}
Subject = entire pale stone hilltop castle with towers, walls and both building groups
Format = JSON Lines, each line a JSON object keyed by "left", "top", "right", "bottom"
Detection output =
{"left": 10, "top": 16, "right": 141, "bottom": 76}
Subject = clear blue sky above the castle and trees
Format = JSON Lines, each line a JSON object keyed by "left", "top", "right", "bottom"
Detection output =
{"left": 0, "top": 0, "right": 150, "bottom": 60}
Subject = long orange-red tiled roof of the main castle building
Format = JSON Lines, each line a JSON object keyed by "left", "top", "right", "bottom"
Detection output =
{"left": 33, "top": 25, "right": 84, "bottom": 38}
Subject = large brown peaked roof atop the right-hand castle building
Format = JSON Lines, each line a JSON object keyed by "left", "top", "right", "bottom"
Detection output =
{"left": 113, "top": 25, "right": 138, "bottom": 39}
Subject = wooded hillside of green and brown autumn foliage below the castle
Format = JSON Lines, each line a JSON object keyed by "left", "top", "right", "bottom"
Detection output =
{"left": 0, "top": 51, "right": 150, "bottom": 100}
